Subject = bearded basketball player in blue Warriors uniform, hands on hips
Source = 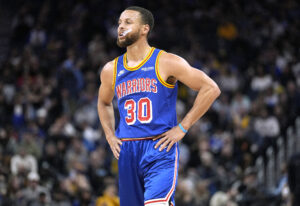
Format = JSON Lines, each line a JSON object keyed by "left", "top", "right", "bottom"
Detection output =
{"left": 98, "top": 7, "right": 220, "bottom": 206}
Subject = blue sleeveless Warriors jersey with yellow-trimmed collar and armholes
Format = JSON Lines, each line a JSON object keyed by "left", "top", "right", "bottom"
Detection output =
{"left": 113, "top": 47, "right": 177, "bottom": 138}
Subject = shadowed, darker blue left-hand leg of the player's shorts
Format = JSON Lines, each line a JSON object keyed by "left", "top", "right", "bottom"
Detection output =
{"left": 118, "top": 141, "right": 144, "bottom": 206}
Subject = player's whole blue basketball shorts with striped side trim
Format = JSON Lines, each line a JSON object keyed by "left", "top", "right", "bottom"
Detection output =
{"left": 118, "top": 139, "right": 179, "bottom": 206}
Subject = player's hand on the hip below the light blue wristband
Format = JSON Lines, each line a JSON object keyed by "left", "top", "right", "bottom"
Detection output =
{"left": 153, "top": 126, "right": 185, "bottom": 152}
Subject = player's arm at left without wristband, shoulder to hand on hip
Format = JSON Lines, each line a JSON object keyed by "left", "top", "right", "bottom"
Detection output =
{"left": 97, "top": 61, "right": 122, "bottom": 159}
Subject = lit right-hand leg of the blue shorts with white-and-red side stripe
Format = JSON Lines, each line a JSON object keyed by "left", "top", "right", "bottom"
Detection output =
{"left": 142, "top": 141, "right": 179, "bottom": 206}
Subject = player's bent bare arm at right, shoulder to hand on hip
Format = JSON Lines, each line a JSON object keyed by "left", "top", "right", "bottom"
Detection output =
{"left": 155, "top": 52, "right": 221, "bottom": 151}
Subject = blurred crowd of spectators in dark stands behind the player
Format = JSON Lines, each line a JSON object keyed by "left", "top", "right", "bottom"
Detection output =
{"left": 0, "top": 0, "right": 300, "bottom": 206}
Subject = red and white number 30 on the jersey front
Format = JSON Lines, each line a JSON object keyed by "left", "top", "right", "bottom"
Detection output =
{"left": 124, "top": 97, "right": 152, "bottom": 125}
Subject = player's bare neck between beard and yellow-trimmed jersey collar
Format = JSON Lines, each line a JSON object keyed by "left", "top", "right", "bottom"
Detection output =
{"left": 127, "top": 41, "right": 151, "bottom": 61}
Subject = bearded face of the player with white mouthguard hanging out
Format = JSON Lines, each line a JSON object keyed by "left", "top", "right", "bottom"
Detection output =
{"left": 117, "top": 10, "right": 142, "bottom": 48}
